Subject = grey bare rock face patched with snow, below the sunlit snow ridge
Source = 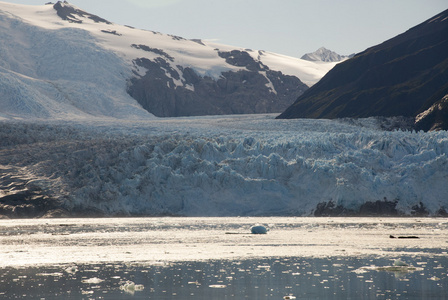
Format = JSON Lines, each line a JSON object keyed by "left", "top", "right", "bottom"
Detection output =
{"left": 128, "top": 49, "right": 308, "bottom": 117}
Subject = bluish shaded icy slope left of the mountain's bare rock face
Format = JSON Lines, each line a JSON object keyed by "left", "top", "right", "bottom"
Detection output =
{"left": 0, "top": 2, "right": 151, "bottom": 120}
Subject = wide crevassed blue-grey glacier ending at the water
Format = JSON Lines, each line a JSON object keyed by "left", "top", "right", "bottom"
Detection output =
{"left": 0, "top": 114, "right": 448, "bottom": 216}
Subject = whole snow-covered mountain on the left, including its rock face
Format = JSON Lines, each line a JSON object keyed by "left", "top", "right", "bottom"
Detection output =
{"left": 0, "top": 1, "right": 334, "bottom": 119}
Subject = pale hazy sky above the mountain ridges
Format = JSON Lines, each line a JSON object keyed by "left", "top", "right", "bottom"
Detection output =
{"left": 4, "top": 0, "right": 448, "bottom": 57}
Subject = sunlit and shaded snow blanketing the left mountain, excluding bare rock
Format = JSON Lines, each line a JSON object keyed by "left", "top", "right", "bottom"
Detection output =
{"left": 0, "top": 2, "right": 335, "bottom": 120}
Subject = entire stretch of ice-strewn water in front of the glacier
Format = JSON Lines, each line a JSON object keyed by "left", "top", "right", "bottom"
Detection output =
{"left": 0, "top": 217, "right": 448, "bottom": 299}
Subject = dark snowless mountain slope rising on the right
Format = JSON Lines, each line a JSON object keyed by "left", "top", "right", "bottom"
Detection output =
{"left": 278, "top": 10, "right": 448, "bottom": 130}
